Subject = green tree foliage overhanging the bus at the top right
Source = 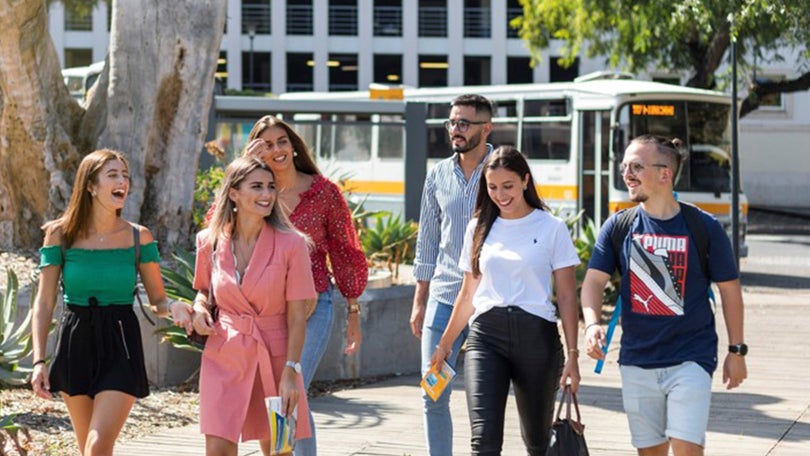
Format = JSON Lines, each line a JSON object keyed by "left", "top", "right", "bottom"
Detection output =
{"left": 510, "top": 0, "right": 810, "bottom": 99}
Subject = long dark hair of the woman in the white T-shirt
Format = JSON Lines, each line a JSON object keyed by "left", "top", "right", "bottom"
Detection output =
{"left": 472, "top": 146, "right": 548, "bottom": 277}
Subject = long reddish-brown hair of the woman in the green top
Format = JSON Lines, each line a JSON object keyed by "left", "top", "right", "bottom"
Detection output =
{"left": 42, "top": 149, "right": 129, "bottom": 247}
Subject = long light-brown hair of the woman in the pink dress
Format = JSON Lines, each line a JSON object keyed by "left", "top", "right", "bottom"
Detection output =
{"left": 208, "top": 157, "right": 308, "bottom": 249}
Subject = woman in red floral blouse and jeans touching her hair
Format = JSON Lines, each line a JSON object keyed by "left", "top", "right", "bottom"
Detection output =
{"left": 244, "top": 116, "right": 368, "bottom": 456}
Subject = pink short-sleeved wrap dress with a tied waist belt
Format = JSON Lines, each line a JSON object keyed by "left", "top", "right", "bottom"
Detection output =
{"left": 194, "top": 225, "right": 317, "bottom": 442}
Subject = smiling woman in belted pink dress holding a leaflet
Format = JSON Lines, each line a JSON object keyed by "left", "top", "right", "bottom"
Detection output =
{"left": 193, "top": 158, "right": 317, "bottom": 455}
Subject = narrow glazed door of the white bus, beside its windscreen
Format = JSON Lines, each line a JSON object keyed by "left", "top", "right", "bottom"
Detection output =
{"left": 578, "top": 111, "right": 610, "bottom": 228}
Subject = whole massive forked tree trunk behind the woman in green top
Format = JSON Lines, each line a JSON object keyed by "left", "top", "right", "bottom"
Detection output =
{"left": 0, "top": 0, "right": 225, "bottom": 249}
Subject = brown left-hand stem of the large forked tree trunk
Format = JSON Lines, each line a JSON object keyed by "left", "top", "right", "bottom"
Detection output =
{"left": 0, "top": 0, "right": 81, "bottom": 250}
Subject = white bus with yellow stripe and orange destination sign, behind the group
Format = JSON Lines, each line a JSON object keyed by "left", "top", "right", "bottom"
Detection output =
{"left": 213, "top": 75, "right": 748, "bottom": 256}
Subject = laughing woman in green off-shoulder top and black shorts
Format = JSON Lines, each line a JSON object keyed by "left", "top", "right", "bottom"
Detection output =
{"left": 31, "top": 149, "right": 192, "bottom": 456}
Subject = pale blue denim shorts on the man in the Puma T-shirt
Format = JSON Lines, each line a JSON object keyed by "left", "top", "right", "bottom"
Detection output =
{"left": 620, "top": 361, "right": 712, "bottom": 448}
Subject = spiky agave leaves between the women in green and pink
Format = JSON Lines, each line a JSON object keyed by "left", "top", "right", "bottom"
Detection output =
{"left": 155, "top": 247, "right": 200, "bottom": 352}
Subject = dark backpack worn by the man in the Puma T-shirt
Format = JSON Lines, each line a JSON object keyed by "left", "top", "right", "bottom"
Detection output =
{"left": 610, "top": 201, "right": 711, "bottom": 281}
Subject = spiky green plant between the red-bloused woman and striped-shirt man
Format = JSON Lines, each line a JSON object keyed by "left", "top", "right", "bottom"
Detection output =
{"left": 360, "top": 214, "right": 419, "bottom": 277}
